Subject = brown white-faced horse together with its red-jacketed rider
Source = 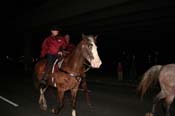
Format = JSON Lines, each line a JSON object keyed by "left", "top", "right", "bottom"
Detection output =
{"left": 34, "top": 25, "right": 102, "bottom": 116}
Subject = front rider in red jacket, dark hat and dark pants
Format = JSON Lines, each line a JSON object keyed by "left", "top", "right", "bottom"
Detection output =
{"left": 40, "top": 26, "right": 68, "bottom": 85}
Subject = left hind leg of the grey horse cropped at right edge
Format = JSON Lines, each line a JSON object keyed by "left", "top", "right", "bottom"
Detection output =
{"left": 152, "top": 91, "right": 165, "bottom": 114}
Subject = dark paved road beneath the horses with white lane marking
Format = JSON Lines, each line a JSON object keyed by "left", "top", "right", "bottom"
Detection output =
{"left": 0, "top": 74, "right": 175, "bottom": 116}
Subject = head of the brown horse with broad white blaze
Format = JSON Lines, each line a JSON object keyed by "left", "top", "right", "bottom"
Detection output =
{"left": 82, "top": 34, "right": 102, "bottom": 68}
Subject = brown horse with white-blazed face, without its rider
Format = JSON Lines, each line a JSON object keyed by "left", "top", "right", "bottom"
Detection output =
{"left": 35, "top": 35, "right": 102, "bottom": 116}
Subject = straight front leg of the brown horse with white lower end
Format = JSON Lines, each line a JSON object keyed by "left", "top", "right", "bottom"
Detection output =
{"left": 71, "top": 87, "right": 78, "bottom": 116}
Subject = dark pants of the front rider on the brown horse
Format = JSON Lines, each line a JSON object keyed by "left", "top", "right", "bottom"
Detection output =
{"left": 42, "top": 54, "right": 56, "bottom": 80}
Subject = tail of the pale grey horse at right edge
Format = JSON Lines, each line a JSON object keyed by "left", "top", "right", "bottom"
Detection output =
{"left": 138, "top": 65, "right": 162, "bottom": 98}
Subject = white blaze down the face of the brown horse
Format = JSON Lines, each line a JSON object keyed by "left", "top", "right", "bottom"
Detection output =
{"left": 89, "top": 37, "right": 102, "bottom": 68}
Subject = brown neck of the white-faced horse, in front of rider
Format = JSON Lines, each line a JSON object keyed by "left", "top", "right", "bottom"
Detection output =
{"left": 62, "top": 44, "right": 84, "bottom": 72}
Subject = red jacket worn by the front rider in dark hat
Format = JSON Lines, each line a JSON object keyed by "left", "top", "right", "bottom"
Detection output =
{"left": 40, "top": 36, "right": 67, "bottom": 58}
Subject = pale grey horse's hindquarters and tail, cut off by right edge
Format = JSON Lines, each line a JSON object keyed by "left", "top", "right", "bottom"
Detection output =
{"left": 139, "top": 64, "right": 175, "bottom": 116}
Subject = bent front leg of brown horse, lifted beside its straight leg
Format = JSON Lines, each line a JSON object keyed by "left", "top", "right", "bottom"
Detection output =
{"left": 51, "top": 90, "right": 65, "bottom": 114}
